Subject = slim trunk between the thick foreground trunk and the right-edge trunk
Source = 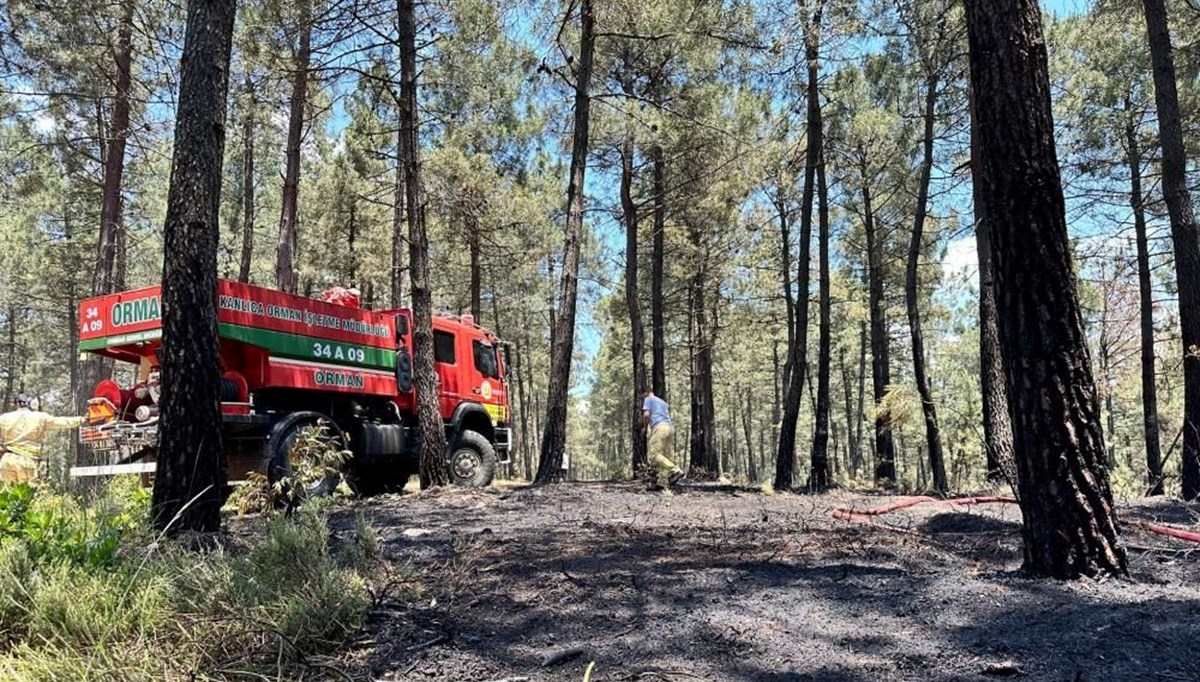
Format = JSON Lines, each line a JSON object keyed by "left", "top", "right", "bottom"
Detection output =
{"left": 1126, "top": 97, "right": 1163, "bottom": 495}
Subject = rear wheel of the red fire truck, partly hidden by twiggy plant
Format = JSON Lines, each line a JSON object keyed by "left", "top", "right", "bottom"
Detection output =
{"left": 264, "top": 412, "right": 346, "bottom": 507}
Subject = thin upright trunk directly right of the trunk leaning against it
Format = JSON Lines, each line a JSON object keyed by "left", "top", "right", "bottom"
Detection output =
{"left": 805, "top": 13, "right": 833, "bottom": 491}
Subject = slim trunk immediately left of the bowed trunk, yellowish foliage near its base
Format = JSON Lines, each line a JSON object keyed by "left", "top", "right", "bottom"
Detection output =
{"left": 859, "top": 162, "right": 896, "bottom": 487}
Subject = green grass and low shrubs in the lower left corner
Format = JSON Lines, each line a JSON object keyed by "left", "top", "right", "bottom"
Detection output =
{"left": 0, "top": 486, "right": 379, "bottom": 681}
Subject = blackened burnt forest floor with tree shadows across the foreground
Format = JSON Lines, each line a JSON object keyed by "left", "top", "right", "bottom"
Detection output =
{"left": 334, "top": 484, "right": 1200, "bottom": 682}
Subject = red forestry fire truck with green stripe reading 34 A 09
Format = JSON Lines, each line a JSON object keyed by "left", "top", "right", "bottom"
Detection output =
{"left": 73, "top": 280, "right": 510, "bottom": 496}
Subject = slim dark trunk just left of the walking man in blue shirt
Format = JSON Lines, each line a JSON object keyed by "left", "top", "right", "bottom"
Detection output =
{"left": 620, "top": 117, "right": 647, "bottom": 478}
